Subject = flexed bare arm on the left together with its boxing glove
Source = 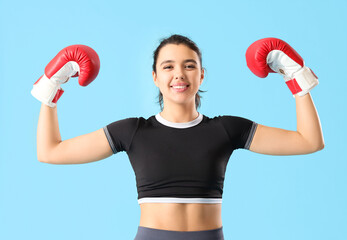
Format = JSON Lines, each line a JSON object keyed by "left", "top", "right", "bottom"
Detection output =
{"left": 31, "top": 45, "right": 112, "bottom": 164}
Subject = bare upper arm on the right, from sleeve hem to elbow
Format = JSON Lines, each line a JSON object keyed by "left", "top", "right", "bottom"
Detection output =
{"left": 249, "top": 124, "right": 319, "bottom": 155}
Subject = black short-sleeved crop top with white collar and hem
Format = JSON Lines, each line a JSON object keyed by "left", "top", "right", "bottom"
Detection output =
{"left": 104, "top": 113, "right": 257, "bottom": 204}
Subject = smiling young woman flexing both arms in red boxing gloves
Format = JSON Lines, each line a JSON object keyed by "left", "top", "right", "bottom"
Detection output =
{"left": 32, "top": 35, "right": 324, "bottom": 240}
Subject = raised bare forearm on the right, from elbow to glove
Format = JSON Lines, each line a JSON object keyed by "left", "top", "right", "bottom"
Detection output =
{"left": 295, "top": 93, "right": 324, "bottom": 150}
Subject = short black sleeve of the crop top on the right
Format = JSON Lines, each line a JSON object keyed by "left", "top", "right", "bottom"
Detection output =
{"left": 220, "top": 116, "right": 258, "bottom": 150}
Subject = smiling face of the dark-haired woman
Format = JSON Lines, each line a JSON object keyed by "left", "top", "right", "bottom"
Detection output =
{"left": 153, "top": 44, "right": 204, "bottom": 109}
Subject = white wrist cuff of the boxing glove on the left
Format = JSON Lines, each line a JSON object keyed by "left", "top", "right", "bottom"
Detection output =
{"left": 31, "top": 75, "right": 60, "bottom": 107}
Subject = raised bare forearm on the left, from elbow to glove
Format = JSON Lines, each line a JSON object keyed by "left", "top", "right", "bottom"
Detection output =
{"left": 37, "top": 104, "right": 61, "bottom": 162}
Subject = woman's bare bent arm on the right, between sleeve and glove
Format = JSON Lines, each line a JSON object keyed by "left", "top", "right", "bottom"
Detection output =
{"left": 249, "top": 93, "right": 324, "bottom": 155}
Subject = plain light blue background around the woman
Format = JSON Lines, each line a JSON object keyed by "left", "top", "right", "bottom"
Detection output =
{"left": 0, "top": 0, "right": 347, "bottom": 240}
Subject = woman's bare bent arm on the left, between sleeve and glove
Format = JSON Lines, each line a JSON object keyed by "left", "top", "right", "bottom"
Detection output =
{"left": 37, "top": 103, "right": 113, "bottom": 164}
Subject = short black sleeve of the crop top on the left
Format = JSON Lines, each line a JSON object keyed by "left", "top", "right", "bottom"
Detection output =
{"left": 103, "top": 118, "right": 138, "bottom": 154}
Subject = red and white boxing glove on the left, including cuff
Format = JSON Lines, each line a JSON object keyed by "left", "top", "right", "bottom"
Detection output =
{"left": 31, "top": 45, "right": 100, "bottom": 107}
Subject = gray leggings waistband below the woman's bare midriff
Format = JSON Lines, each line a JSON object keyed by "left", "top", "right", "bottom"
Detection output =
{"left": 134, "top": 226, "right": 224, "bottom": 240}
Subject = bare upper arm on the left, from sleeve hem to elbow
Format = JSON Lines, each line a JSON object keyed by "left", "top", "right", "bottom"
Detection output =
{"left": 44, "top": 128, "right": 113, "bottom": 164}
